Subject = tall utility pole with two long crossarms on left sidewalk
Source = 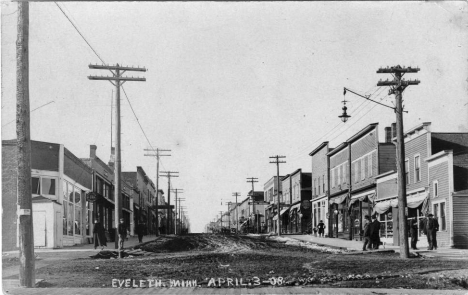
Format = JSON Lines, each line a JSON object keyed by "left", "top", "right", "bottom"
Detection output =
{"left": 88, "top": 64, "right": 146, "bottom": 253}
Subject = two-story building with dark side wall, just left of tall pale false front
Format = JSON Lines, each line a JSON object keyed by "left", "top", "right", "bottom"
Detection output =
{"left": 280, "top": 169, "right": 312, "bottom": 233}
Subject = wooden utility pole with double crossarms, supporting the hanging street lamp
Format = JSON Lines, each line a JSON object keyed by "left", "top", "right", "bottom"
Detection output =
{"left": 377, "top": 65, "right": 420, "bottom": 258}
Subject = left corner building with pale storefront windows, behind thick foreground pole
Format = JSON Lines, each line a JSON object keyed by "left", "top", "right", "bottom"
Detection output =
{"left": 2, "top": 140, "right": 92, "bottom": 251}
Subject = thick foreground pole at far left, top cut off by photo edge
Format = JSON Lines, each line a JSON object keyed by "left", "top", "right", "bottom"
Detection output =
{"left": 16, "top": 1, "right": 36, "bottom": 288}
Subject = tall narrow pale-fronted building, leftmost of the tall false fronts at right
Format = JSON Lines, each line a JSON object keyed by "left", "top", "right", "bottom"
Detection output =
{"left": 309, "top": 141, "right": 333, "bottom": 236}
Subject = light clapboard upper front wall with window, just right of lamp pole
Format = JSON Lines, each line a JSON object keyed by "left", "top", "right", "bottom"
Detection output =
{"left": 405, "top": 133, "right": 430, "bottom": 191}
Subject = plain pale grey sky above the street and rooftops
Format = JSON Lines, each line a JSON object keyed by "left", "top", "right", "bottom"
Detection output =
{"left": 1, "top": 1, "right": 468, "bottom": 232}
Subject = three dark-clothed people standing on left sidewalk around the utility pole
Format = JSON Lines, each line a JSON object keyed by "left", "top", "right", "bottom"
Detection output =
{"left": 93, "top": 218, "right": 145, "bottom": 250}
